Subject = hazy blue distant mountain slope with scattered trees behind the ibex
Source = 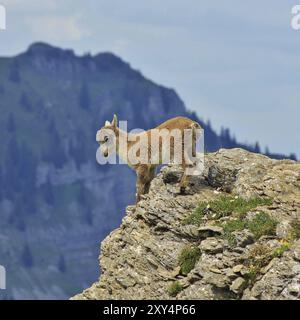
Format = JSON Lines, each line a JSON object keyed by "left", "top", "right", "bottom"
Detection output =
{"left": 0, "top": 43, "right": 296, "bottom": 298}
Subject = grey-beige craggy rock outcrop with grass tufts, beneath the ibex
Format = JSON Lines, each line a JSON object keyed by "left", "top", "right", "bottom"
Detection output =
{"left": 73, "top": 149, "right": 300, "bottom": 299}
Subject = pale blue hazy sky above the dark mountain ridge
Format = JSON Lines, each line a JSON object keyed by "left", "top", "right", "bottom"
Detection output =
{"left": 0, "top": 0, "right": 300, "bottom": 156}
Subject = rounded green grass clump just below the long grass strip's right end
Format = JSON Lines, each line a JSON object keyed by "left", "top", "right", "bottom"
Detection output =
{"left": 247, "top": 212, "right": 278, "bottom": 239}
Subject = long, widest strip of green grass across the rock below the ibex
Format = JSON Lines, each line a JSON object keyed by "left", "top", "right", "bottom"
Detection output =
{"left": 184, "top": 196, "right": 272, "bottom": 225}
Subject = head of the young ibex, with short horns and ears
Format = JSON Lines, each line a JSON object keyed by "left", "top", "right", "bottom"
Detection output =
{"left": 96, "top": 115, "right": 118, "bottom": 157}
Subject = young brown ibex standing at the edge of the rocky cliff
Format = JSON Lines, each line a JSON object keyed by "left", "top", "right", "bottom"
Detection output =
{"left": 96, "top": 115, "right": 201, "bottom": 203}
